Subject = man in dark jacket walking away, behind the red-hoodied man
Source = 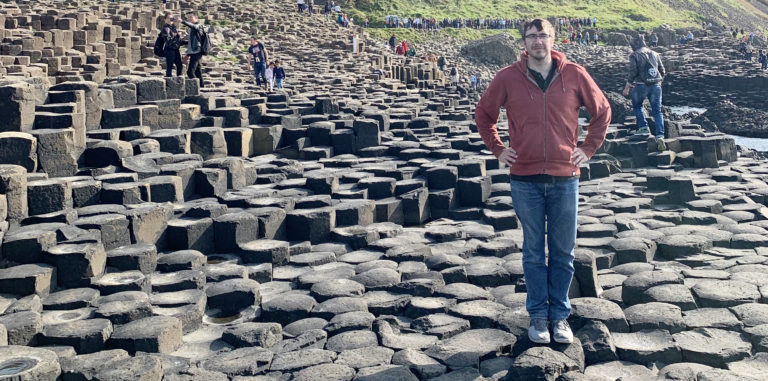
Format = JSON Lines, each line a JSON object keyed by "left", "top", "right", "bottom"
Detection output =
{"left": 622, "top": 35, "right": 666, "bottom": 151}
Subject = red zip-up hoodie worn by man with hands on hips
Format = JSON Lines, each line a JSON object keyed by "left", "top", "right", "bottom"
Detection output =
{"left": 475, "top": 50, "right": 611, "bottom": 176}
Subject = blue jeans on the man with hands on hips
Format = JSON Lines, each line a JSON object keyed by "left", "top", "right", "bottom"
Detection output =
{"left": 510, "top": 179, "right": 579, "bottom": 320}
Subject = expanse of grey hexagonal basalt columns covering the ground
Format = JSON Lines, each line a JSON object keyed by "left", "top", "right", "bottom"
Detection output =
{"left": 0, "top": 1, "right": 768, "bottom": 380}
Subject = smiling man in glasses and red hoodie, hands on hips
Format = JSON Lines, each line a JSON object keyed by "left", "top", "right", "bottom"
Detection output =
{"left": 475, "top": 19, "right": 611, "bottom": 344}
